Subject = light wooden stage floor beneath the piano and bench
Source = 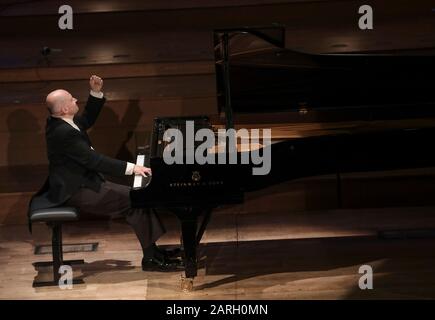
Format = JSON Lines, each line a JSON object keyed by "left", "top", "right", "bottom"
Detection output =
{"left": 0, "top": 207, "right": 435, "bottom": 299}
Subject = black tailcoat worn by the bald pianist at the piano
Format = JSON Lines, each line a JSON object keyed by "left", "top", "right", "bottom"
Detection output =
{"left": 29, "top": 96, "right": 127, "bottom": 218}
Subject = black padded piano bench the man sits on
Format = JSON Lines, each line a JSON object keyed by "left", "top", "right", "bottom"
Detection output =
{"left": 29, "top": 207, "right": 84, "bottom": 287}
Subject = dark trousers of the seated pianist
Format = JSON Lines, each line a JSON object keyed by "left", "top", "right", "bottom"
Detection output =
{"left": 66, "top": 181, "right": 166, "bottom": 254}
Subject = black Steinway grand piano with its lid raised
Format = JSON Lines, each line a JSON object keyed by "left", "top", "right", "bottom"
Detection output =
{"left": 130, "top": 26, "right": 435, "bottom": 290}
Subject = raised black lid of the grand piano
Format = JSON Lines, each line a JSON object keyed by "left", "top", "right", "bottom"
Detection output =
{"left": 214, "top": 26, "right": 435, "bottom": 126}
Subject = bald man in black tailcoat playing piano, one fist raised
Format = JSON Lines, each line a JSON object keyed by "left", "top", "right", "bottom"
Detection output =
{"left": 30, "top": 75, "right": 180, "bottom": 271}
